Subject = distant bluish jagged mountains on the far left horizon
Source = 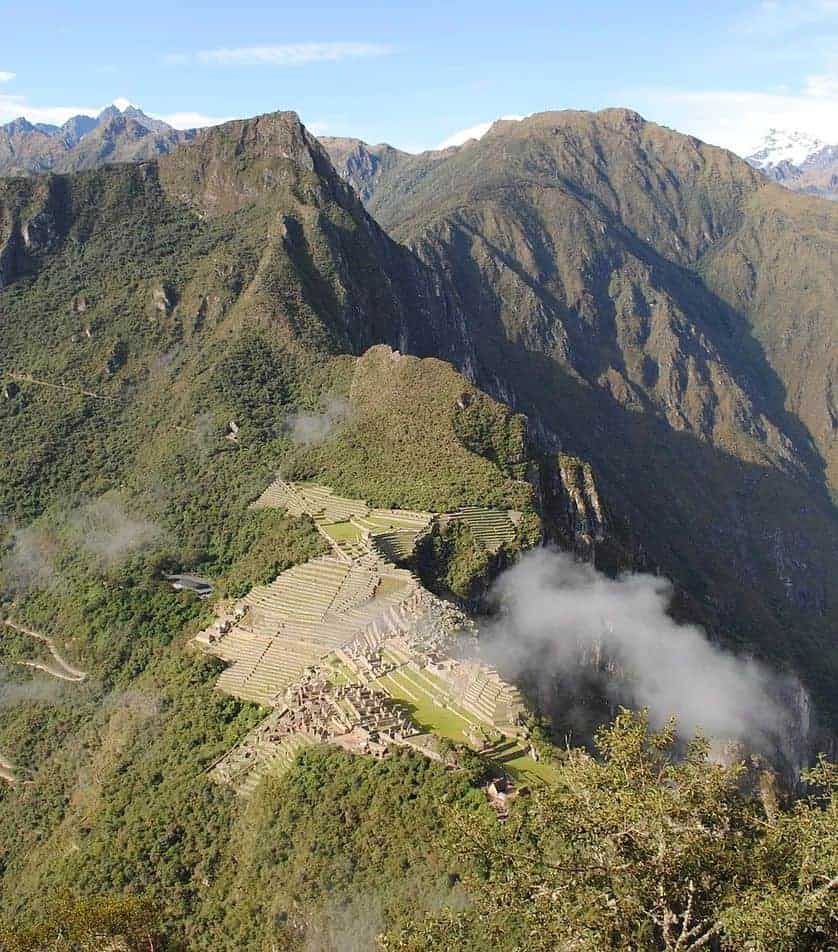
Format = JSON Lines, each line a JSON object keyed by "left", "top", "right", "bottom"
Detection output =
{"left": 0, "top": 105, "right": 194, "bottom": 175}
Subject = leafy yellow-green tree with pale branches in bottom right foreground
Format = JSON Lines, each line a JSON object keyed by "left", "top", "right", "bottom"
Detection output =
{"left": 382, "top": 711, "right": 838, "bottom": 952}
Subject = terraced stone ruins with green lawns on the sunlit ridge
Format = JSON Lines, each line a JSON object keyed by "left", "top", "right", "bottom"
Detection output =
{"left": 196, "top": 479, "right": 548, "bottom": 795}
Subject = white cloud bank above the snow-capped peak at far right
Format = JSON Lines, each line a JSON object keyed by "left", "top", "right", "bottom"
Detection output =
{"left": 627, "top": 74, "right": 838, "bottom": 155}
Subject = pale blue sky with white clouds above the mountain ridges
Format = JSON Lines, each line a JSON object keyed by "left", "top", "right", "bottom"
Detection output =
{"left": 0, "top": 0, "right": 838, "bottom": 154}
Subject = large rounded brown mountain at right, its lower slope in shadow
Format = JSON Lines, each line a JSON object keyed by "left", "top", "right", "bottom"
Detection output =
{"left": 344, "top": 110, "right": 838, "bottom": 724}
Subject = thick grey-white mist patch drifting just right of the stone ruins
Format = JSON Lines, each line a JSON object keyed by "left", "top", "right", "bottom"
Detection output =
{"left": 484, "top": 549, "right": 791, "bottom": 749}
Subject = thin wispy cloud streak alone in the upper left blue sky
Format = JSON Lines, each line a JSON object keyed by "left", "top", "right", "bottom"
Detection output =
{"left": 165, "top": 42, "right": 391, "bottom": 67}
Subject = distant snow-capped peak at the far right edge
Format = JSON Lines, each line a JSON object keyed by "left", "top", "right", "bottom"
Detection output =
{"left": 746, "top": 129, "right": 838, "bottom": 200}
